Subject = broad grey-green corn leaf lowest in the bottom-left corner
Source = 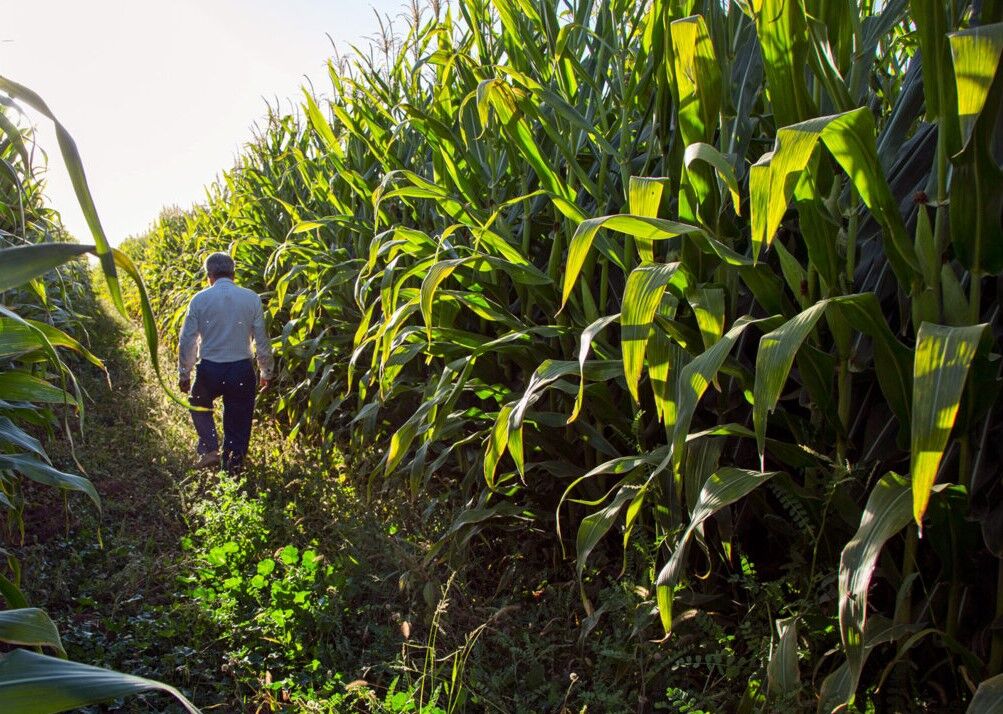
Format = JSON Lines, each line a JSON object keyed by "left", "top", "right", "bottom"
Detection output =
{"left": 0, "top": 650, "right": 199, "bottom": 714}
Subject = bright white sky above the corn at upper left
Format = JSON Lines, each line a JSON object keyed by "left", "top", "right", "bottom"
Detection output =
{"left": 0, "top": 0, "right": 405, "bottom": 244}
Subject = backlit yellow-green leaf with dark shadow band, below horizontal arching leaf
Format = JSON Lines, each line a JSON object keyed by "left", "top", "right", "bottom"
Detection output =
{"left": 620, "top": 263, "right": 679, "bottom": 402}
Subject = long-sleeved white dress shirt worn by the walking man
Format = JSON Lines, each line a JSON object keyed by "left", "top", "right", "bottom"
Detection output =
{"left": 178, "top": 278, "right": 275, "bottom": 379}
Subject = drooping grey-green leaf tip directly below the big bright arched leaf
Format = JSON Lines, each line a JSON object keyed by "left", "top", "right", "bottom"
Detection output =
{"left": 752, "top": 301, "right": 827, "bottom": 459}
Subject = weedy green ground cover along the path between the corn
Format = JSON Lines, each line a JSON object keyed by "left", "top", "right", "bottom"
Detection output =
{"left": 15, "top": 303, "right": 726, "bottom": 713}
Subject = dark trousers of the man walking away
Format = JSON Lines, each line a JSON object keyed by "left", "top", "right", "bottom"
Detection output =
{"left": 191, "top": 359, "right": 257, "bottom": 469}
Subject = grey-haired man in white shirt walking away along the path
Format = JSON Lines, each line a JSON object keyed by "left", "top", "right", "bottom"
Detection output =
{"left": 178, "top": 253, "right": 274, "bottom": 472}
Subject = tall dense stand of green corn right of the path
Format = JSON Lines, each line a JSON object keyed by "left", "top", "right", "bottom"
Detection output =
{"left": 0, "top": 0, "right": 1003, "bottom": 712}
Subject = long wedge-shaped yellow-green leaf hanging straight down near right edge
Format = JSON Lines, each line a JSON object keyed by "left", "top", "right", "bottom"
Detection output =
{"left": 910, "top": 322, "right": 987, "bottom": 532}
